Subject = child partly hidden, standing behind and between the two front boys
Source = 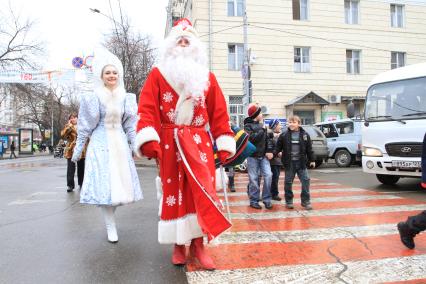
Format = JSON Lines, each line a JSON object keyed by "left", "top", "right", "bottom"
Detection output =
{"left": 269, "top": 119, "right": 283, "bottom": 201}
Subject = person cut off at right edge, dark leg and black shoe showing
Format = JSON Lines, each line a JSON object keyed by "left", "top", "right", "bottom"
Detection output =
{"left": 397, "top": 133, "right": 426, "bottom": 249}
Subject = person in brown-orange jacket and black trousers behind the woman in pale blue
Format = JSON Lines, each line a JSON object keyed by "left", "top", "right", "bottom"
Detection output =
{"left": 58, "top": 113, "right": 86, "bottom": 192}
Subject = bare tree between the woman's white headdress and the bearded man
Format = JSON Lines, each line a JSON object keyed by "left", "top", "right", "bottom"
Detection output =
{"left": 104, "top": 12, "right": 155, "bottom": 97}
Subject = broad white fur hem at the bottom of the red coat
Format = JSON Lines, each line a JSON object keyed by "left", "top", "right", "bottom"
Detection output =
{"left": 158, "top": 214, "right": 204, "bottom": 245}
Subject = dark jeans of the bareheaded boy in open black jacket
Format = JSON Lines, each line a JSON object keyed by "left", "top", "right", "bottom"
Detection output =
{"left": 284, "top": 161, "right": 311, "bottom": 204}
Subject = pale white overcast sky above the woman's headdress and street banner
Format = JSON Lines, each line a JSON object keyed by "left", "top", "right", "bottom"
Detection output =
{"left": 5, "top": 0, "right": 168, "bottom": 70}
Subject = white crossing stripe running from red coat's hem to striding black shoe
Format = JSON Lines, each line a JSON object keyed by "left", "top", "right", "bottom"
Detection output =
{"left": 213, "top": 224, "right": 398, "bottom": 245}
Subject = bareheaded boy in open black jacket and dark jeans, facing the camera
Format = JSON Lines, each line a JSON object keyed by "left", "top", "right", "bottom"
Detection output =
{"left": 275, "top": 115, "right": 315, "bottom": 210}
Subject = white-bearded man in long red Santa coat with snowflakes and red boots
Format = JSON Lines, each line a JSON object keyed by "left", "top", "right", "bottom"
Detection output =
{"left": 135, "top": 19, "right": 235, "bottom": 270}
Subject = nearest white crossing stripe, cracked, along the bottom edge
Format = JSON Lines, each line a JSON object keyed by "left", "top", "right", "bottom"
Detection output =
{"left": 186, "top": 255, "right": 426, "bottom": 284}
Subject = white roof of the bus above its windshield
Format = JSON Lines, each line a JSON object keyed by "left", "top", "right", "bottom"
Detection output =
{"left": 370, "top": 62, "right": 426, "bottom": 86}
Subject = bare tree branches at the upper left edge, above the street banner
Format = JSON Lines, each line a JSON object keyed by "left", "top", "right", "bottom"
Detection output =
{"left": 0, "top": 3, "right": 44, "bottom": 70}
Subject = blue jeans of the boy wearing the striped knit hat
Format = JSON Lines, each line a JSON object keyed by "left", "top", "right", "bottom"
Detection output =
{"left": 247, "top": 157, "right": 272, "bottom": 204}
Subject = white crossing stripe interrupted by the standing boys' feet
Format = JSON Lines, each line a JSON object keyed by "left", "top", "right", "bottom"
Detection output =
{"left": 229, "top": 195, "right": 402, "bottom": 206}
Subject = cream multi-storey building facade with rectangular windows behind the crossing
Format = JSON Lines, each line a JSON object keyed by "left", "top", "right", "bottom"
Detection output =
{"left": 166, "top": 0, "right": 426, "bottom": 124}
